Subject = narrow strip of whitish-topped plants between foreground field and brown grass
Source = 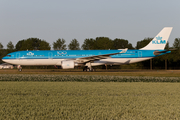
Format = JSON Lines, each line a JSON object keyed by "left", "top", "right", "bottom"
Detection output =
{"left": 0, "top": 74, "right": 180, "bottom": 82}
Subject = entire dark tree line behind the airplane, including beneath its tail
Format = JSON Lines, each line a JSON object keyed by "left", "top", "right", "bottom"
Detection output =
{"left": 0, "top": 37, "right": 180, "bottom": 69}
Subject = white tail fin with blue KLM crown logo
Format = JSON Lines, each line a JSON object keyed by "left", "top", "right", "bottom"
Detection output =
{"left": 141, "top": 27, "right": 172, "bottom": 50}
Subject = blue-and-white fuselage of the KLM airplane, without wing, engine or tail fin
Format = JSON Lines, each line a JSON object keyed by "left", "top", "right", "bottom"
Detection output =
{"left": 2, "top": 50, "right": 170, "bottom": 66}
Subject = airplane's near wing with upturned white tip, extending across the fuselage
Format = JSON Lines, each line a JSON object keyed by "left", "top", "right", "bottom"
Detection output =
{"left": 76, "top": 48, "right": 128, "bottom": 61}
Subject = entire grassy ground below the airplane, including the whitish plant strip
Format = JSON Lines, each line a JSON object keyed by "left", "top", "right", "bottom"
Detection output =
{"left": 0, "top": 69, "right": 180, "bottom": 120}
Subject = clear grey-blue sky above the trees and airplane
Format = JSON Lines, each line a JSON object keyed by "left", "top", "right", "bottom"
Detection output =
{"left": 0, "top": 0, "right": 180, "bottom": 48}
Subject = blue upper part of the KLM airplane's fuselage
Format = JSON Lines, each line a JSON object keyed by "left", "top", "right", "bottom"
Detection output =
{"left": 2, "top": 50, "right": 167, "bottom": 60}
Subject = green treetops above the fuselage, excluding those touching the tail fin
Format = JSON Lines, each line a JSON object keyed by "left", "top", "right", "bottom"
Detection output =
{"left": 0, "top": 37, "right": 135, "bottom": 51}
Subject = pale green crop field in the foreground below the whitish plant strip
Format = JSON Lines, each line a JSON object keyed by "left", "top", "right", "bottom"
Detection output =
{"left": 0, "top": 82, "right": 180, "bottom": 120}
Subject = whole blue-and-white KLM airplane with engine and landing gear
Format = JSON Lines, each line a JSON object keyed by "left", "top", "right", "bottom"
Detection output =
{"left": 2, "top": 27, "right": 172, "bottom": 71}
